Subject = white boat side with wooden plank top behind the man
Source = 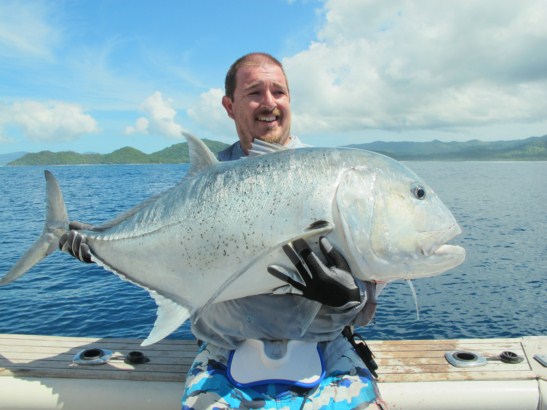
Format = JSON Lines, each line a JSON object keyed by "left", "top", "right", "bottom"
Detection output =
{"left": 0, "top": 334, "right": 547, "bottom": 410}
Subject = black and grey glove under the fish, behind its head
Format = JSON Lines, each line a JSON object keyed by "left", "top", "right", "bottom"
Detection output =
{"left": 268, "top": 237, "right": 361, "bottom": 308}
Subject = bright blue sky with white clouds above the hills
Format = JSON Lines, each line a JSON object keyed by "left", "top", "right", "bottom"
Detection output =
{"left": 0, "top": 0, "right": 547, "bottom": 154}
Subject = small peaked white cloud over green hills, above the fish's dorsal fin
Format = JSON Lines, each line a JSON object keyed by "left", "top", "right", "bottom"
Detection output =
{"left": 125, "top": 91, "right": 184, "bottom": 139}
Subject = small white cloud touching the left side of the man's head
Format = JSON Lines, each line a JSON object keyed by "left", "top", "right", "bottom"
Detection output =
{"left": 188, "top": 88, "right": 234, "bottom": 135}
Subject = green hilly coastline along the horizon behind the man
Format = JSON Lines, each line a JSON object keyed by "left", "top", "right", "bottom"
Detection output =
{"left": 4, "top": 135, "right": 547, "bottom": 166}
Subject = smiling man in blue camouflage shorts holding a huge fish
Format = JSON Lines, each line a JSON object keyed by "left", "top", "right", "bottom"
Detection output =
{"left": 183, "top": 53, "right": 382, "bottom": 410}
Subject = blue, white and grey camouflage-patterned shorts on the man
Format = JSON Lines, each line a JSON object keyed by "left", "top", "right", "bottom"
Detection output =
{"left": 182, "top": 338, "right": 385, "bottom": 410}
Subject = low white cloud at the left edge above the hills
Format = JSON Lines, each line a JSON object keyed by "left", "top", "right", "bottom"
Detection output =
{"left": 0, "top": 101, "right": 99, "bottom": 142}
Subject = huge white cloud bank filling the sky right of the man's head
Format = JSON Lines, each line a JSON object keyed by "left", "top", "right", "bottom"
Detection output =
{"left": 283, "top": 0, "right": 547, "bottom": 133}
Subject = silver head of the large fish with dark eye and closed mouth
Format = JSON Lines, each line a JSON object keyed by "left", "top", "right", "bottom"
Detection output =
{"left": 336, "top": 158, "right": 465, "bottom": 283}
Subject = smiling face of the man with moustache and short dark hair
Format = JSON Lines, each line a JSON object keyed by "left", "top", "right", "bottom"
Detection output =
{"left": 222, "top": 62, "right": 291, "bottom": 151}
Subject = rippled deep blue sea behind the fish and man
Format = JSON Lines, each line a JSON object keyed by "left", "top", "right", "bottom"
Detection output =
{"left": 0, "top": 162, "right": 547, "bottom": 340}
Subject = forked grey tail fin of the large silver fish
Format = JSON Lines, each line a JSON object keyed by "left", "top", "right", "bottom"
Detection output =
{"left": 0, "top": 171, "right": 68, "bottom": 285}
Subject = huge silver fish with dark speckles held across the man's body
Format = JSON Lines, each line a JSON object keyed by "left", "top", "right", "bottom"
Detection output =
{"left": 0, "top": 136, "right": 465, "bottom": 345}
